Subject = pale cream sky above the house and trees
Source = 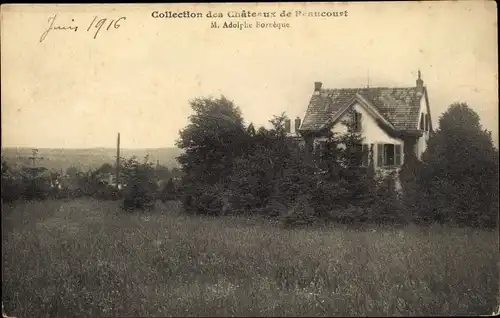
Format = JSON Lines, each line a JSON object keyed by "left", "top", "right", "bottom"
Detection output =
{"left": 1, "top": 1, "right": 498, "bottom": 148}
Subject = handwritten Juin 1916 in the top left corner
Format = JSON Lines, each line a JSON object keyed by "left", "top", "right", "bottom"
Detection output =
{"left": 40, "top": 14, "right": 127, "bottom": 43}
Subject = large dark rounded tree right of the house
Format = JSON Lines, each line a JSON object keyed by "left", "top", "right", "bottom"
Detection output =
{"left": 419, "top": 103, "right": 498, "bottom": 226}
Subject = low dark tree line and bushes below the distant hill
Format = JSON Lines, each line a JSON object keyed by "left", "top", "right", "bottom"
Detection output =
{"left": 2, "top": 157, "right": 182, "bottom": 210}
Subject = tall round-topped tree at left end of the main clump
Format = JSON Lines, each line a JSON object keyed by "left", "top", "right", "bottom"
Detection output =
{"left": 176, "top": 96, "right": 248, "bottom": 212}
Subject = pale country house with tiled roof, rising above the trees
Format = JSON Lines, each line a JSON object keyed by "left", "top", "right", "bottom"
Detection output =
{"left": 296, "top": 71, "right": 433, "bottom": 169}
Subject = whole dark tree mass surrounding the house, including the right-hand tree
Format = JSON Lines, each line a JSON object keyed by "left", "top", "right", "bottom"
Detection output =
{"left": 177, "top": 96, "right": 498, "bottom": 227}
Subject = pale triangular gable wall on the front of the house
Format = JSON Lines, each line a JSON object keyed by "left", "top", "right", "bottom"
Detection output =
{"left": 331, "top": 102, "right": 402, "bottom": 144}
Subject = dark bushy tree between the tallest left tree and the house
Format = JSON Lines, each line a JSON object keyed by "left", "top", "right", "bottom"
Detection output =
{"left": 230, "top": 113, "right": 304, "bottom": 213}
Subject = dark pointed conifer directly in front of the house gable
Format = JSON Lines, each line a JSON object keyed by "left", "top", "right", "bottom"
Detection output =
{"left": 307, "top": 110, "right": 376, "bottom": 223}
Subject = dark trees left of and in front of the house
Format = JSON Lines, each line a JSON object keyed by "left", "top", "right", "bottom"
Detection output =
{"left": 175, "top": 99, "right": 382, "bottom": 225}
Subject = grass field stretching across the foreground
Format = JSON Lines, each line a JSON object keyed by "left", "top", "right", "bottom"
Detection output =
{"left": 2, "top": 200, "right": 499, "bottom": 318}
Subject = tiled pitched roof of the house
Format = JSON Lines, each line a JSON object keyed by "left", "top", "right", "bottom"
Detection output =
{"left": 300, "top": 87, "right": 427, "bottom": 131}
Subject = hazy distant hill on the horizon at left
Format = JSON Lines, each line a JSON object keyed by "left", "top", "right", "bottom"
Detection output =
{"left": 2, "top": 147, "right": 182, "bottom": 171}
